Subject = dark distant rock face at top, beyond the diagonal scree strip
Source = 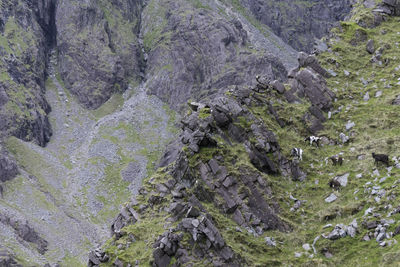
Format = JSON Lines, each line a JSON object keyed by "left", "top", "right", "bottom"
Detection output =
{"left": 240, "top": 0, "right": 352, "bottom": 52}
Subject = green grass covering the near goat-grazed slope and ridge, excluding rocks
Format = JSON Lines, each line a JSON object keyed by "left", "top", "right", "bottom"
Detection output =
{"left": 99, "top": 4, "right": 400, "bottom": 266}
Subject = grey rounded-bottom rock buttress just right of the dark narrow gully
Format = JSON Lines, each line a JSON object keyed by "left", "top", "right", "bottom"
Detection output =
{"left": 56, "top": 0, "right": 142, "bottom": 109}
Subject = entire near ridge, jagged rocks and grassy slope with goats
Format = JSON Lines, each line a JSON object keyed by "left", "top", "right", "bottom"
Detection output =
{"left": 89, "top": 0, "right": 400, "bottom": 266}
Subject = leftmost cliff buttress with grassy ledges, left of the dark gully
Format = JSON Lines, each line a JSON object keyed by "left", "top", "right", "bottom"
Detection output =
{"left": 0, "top": 0, "right": 53, "bottom": 146}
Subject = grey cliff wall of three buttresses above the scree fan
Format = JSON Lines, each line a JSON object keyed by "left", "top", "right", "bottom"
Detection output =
{"left": 0, "top": 0, "right": 296, "bottom": 146}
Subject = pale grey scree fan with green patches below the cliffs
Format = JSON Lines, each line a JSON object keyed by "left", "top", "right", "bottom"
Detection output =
{"left": 0, "top": 50, "right": 175, "bottom": 264}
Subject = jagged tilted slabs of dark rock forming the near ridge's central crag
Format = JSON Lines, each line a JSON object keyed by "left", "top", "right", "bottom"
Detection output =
{"left": 89, "top": 75, "right": 318, "bottom": 266}
